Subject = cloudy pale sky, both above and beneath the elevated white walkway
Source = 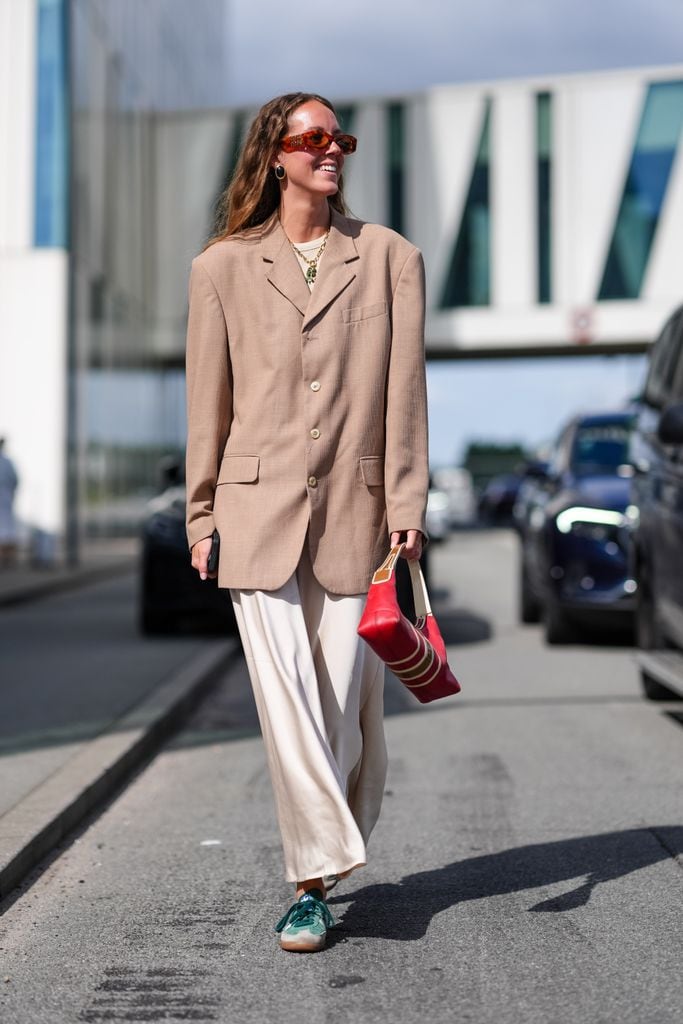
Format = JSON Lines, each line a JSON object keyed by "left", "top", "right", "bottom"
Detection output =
{"left": 226, "top": 0, "right": 683, "bottom": 465}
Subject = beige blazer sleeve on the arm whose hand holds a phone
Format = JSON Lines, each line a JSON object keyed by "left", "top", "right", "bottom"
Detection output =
{"left": 185, "top": 259, "right": 232, "bottom": 548}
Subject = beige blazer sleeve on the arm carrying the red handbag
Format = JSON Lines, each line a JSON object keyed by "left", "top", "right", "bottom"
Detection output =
{"left": 384, "top": 249, "right": 429, "bottom": 536}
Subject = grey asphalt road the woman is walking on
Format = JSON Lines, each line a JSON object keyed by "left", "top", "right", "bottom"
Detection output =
{"left": 0, "top": 531, "right": 683, "bottom": 1024}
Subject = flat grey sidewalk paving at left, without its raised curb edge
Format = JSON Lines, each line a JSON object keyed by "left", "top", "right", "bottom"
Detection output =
{"left": 0, "top": 572, "right": 233, "bottom": 816}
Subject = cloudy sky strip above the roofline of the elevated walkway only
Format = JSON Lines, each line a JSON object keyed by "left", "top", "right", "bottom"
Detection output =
{"left": 226, "top": 0, "right": 683, "bottom": 104}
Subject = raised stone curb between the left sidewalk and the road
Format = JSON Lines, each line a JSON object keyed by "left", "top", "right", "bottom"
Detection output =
{"left": 0, "top": 639, "right": 240, "bottom": 900}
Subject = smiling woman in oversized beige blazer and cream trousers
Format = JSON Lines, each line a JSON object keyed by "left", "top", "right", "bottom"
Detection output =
{"left": 186, "top": 93, "right": 428, "bottom": 951}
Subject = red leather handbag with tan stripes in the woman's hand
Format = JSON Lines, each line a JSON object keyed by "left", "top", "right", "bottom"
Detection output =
{"left": 358, "top": 544, "right": 461, "bottom": 703}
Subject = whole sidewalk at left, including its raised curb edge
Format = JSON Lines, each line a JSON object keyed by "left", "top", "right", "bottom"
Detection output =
{"left": 0, "top": 557, "right": 239, "bottom": 899}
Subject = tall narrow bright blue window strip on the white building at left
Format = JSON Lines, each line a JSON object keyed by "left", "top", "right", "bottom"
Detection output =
{"left": 34, "top": 0, "right": 68, "bottom": 246}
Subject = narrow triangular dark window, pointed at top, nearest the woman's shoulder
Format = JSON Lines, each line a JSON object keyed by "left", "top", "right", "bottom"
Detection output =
{"left": 439, "top": 100, "right": 490, "bottom": 309}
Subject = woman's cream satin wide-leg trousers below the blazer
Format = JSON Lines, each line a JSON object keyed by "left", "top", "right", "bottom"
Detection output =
{"left": 230, "top": 547, "right": 387, "bottom": 882}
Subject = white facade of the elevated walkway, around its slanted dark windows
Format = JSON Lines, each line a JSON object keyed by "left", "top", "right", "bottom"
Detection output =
{"left": 417, "top": 67, "right": 683, "bottom": 355}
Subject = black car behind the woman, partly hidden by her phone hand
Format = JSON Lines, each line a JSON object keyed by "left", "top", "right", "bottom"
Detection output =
{"left": 139, "top": 485, "right": 237, "bottom": 634}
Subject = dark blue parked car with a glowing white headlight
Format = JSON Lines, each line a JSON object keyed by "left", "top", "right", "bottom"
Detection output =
{"left": 518, "top": 412, "right": 636, "bottom": 643}
